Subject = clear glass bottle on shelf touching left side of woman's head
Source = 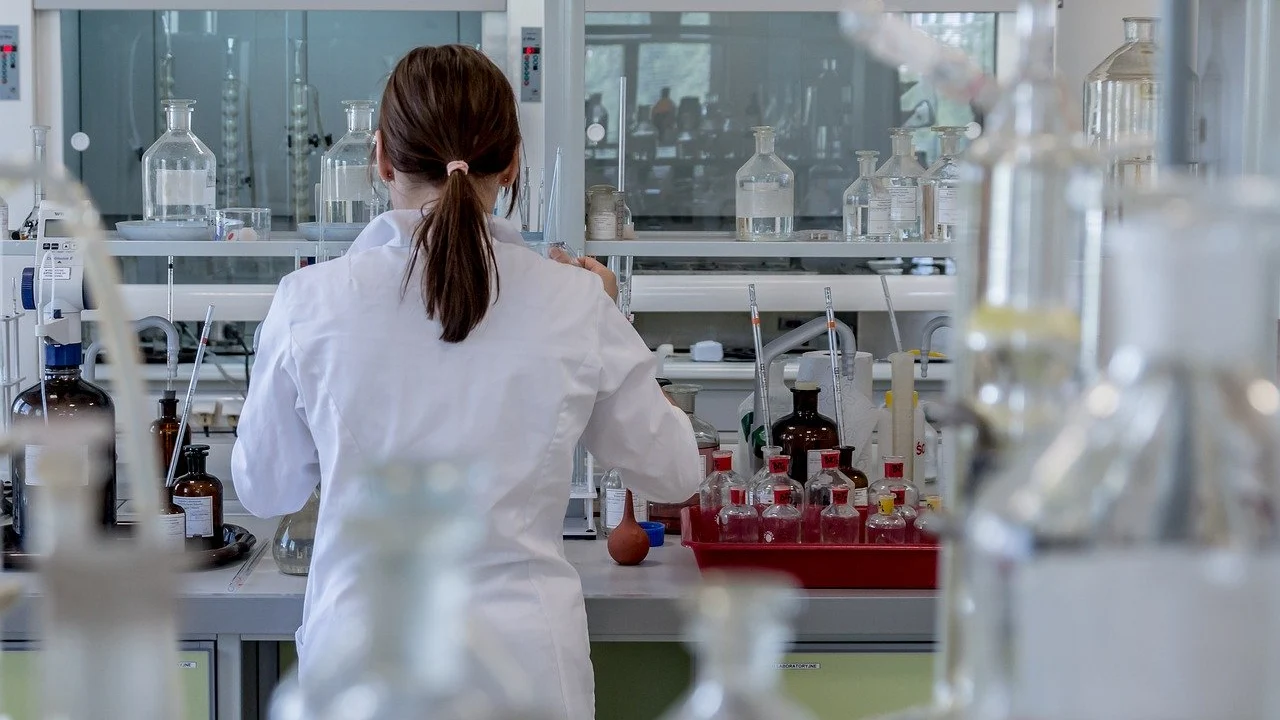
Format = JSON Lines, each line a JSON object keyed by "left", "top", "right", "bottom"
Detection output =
{"left": 320, "top": 100, "right": 376, "bottom": 224}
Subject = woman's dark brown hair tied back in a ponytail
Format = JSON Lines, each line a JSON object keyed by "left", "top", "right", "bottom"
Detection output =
{"left": 378, "top": 45, "right": 520, "bottom": 342}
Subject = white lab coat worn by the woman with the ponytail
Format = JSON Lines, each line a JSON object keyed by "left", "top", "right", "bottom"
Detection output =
{"left": 232, "top": 210, "right": 701, "bottom": 720}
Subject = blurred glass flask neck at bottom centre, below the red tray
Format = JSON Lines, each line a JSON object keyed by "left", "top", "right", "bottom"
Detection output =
{"left": 659, "top": 571, "right": 814, "bottom": 720}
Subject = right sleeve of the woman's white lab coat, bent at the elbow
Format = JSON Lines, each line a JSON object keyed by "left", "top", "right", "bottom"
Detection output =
{"left": 582, "top": 288, "right": 703, "bottom": 502}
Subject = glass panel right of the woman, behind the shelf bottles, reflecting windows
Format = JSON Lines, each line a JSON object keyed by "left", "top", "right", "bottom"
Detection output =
{"left": 585, "top": 12, "right": 1012, "bottom": 231}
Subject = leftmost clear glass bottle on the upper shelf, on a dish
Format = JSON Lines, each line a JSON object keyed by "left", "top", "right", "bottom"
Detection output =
{"left": 142, "top": 100, "right": 218, "bottom": 223}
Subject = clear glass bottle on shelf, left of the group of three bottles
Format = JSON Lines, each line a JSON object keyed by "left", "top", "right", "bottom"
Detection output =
{"left": 735, "top": 127, "right": 796, "bottom": 241}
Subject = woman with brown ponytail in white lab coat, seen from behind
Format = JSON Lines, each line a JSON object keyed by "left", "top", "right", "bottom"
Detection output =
{"left": 232, "top": 45, "right": 701, "bottom": 720}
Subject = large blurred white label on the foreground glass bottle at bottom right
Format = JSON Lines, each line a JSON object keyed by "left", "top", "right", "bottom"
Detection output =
{"left": 1011, "top": 550, "right": 1276, "bottom": 720}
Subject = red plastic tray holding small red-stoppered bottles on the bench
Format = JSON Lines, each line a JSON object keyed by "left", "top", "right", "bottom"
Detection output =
{"left": 680, "top": 507, "right": 938, "bottom": 589}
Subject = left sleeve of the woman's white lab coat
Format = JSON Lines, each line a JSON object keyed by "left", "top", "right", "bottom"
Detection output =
{"left": 232, "top": 279, "right": 320, "bottom": 518}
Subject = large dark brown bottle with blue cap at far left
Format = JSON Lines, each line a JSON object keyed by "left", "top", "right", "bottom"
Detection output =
{"left": 5, "top": 343, "right": 115, "bottom": 552}
